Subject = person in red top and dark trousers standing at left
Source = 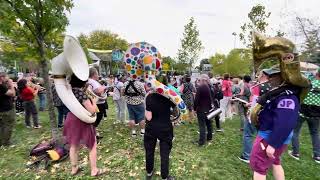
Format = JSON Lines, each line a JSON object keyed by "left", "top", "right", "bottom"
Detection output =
{"left": 17, "top": 79, "right": 41, "bottom": 129}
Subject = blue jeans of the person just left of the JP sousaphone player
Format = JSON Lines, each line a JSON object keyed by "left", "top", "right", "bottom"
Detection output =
{"left": 242, "top": 119, "right": 257, "bottom": 160}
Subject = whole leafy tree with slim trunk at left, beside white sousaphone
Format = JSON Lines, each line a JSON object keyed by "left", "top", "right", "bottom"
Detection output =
{"left": 0, "top": 0, "right": 73, "bottom": 140}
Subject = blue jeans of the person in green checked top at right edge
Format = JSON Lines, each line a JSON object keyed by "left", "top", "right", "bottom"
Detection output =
{"left": 292, "top": 116, "right": 320, "bottom": 157}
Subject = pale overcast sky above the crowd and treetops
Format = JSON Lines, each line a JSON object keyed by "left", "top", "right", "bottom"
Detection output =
{"left": 67, "top": 0, "right": 320, "bottom": 62}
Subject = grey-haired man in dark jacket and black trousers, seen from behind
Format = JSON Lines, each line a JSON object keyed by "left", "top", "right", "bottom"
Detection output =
{"left": 194, "top": 74, "right": 212, "bottom": 146}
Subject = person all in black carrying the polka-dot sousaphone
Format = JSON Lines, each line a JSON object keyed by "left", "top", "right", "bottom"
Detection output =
{"left": 144, "top": 93, "right": 175, "bottom": 180}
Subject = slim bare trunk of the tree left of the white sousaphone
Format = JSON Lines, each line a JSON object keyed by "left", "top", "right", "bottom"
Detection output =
{"left": 39, "top": 39, "right": 61, "bottom": 141}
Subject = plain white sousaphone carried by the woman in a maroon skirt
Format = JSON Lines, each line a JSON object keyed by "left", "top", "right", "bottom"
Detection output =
{"left": 51, "top": 36, "right": 96, "bottom": 123}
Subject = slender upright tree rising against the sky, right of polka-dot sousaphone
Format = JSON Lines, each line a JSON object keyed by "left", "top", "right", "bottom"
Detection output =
{"left": 178, "top": 17, "right": 203, "bottom": 72}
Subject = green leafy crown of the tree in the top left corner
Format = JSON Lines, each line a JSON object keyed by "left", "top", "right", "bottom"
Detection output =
{"left": 0, "top": 0, "right": 73, "bottom": 60}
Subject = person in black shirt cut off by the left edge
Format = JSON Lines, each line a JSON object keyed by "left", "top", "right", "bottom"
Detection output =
{"left": 0, "top": 73, "right": 16, "bottom": 146}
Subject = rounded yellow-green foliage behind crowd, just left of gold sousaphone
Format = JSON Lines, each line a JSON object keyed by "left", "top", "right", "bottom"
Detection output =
{"left": 209, "top": 49, "right": 252, "bottom": 76}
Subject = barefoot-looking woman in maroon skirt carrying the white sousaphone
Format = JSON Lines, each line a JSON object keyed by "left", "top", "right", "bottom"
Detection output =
{"left": 63, "top": 75, "right": 106, "bottom": 176}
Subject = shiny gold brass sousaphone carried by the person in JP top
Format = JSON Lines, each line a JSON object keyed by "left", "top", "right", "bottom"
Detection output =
{"left": 250, "top": 32, "right": 310, "bottom": 125}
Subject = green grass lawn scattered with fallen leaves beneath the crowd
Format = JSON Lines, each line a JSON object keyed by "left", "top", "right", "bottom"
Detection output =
{"left": 0, "top": 101, "right": 320, "bottom": 180}
